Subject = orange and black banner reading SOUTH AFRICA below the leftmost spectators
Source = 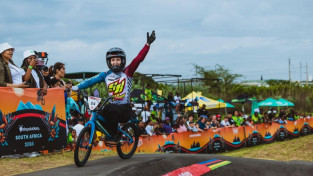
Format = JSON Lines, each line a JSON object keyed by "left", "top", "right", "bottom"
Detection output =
{"left": 0, "top": 88, "right": 66, "bottom": 155}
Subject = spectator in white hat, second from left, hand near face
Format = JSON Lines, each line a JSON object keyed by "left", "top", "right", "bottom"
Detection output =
{"left": 21, "top": 50, "right": 48, "bottom": 94}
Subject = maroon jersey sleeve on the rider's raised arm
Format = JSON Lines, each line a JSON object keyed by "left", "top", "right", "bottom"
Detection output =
{"left": 124, "top": 44, "right": 150, "bottom": 77}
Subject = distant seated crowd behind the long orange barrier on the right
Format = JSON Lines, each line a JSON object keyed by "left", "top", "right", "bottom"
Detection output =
{"left": 136, "top": 94, "right": 310, "bottom": 137}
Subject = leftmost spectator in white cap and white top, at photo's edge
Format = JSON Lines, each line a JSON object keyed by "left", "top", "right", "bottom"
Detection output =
{"left": 0, "top": 43, "right": 35, "bottom": 88}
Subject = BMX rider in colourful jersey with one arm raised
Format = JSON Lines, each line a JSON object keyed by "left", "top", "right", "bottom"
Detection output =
{"left": 72, "top": 31, "right": 156, "bottom": 142}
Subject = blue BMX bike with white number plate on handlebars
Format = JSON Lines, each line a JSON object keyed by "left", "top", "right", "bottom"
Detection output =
{"left": 74, "top": 92, "right": 139, "bottom": 167}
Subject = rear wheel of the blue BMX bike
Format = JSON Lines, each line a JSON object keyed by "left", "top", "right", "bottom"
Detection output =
{"left": 116, "top": 123, "right": 139, "bottom": 159}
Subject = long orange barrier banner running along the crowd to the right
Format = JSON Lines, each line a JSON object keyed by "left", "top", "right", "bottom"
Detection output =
{"left": 94, "top": 118, "right": 313, "bottom": 153}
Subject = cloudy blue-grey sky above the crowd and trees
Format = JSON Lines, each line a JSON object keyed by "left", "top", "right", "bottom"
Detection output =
{"left": 0, "top": 0, "right": 313, "bottom": 80}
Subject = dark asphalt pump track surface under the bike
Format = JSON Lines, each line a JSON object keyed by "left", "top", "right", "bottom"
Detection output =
{"left": 22, "top": 153, "right": 313, "bottom": 176}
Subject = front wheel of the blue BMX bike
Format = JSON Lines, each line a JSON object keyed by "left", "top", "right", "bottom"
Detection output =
{"left": 74, "top": 126, "right": 92, "bottom": 167}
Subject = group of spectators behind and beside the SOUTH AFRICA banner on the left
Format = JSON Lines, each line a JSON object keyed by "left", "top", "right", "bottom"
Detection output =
{"left": 0, "top": 43, "right": 81, "bottom": 151}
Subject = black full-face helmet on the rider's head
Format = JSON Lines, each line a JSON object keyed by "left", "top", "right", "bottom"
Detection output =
{"left": 106, "top": 47, "right": 126, "bottom": 72}
